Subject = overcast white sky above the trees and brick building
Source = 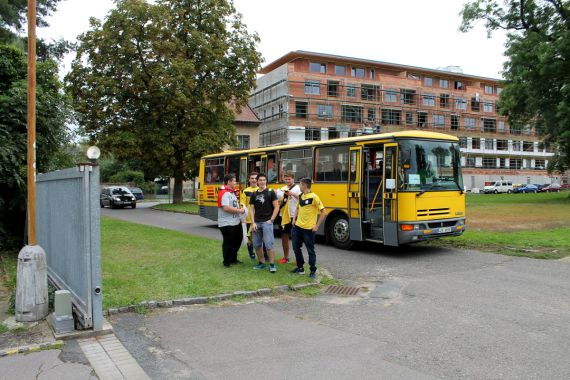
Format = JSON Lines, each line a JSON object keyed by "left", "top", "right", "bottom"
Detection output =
{"left": 37, "top": 0, "right": 505, "bottom": 78}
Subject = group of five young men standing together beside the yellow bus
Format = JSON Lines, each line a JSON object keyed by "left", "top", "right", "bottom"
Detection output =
{"left": 218, "top": 171, "right": 326, "bottom": 278}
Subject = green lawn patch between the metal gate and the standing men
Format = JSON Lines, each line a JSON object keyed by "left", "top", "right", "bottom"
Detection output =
{"left": 101, "top": 217, "right": 316, "bottom": 309}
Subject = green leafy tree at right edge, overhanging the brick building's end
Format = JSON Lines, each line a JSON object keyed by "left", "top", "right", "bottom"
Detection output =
{"left": 460, "top": 0, "right": 570, "bottom": 172}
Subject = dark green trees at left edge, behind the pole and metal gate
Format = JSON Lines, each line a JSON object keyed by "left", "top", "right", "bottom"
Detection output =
{"left": 0, "top": 45, "right": 74, "bottom": 248}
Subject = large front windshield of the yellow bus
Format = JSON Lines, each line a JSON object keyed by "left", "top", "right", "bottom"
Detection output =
{"left": 400, "top": 140, "right": 463, "bottom": 192}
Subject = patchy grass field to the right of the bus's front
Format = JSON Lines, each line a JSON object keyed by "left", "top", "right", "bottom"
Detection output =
{"left": 428, "top": 192, "right": 570, "bottom": 259}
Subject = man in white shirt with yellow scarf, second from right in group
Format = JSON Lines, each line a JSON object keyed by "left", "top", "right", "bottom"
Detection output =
{"left": 279, "top": 170, "right": 301, "bottom": 264}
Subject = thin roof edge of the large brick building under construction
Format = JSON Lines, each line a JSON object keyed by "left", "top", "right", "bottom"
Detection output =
{"left": 259, "top": 50, "right": 502, "bottom": 82}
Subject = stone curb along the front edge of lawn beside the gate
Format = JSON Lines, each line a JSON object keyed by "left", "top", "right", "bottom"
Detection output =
{"left": 102, "top": 282, "right": 320, "bottom": 318}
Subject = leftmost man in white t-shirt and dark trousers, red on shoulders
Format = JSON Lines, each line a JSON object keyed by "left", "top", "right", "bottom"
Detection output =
{"left": 218, "top": 174, "right": 246, "bottom": 268}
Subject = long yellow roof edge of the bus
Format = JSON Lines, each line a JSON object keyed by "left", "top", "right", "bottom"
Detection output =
{"left": 203, "top": 130, "right": 459, "bottom": 158}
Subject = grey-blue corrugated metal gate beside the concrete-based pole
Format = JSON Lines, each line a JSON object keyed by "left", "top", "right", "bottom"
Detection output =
{"left": 36, "top": 164, "right": 103, "bottom": 330}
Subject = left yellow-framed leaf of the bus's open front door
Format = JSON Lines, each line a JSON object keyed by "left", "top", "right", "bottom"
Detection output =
{"left": 348, "top": 146, "right": 362, "bottom": 241}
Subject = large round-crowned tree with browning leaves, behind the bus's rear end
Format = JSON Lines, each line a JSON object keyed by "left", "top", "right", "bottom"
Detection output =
{"left": 66, "top": 0, "right": 261, "bottom": 202}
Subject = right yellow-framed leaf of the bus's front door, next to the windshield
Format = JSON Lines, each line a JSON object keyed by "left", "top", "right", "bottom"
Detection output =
{"left": 382, "top": 143, "right": 398, "bottom": 246}
